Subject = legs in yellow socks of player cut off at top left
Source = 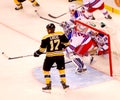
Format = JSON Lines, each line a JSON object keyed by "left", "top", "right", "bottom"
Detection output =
{"left": 14, "top": 0, "right": 40, "bottom": 10}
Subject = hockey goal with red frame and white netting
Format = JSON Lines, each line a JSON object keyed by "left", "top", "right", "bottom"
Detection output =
{"left": 75, "top": 20, "right": 113, "bottom": 76}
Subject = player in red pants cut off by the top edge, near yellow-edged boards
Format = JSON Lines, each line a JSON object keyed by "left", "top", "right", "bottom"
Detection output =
{"left": 83, "top": 0, "right": 112, "bottom": 20}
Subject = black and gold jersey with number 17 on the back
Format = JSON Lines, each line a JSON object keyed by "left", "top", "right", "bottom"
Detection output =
{"left": 40, "top": 32, "right": 69, "bottom": 57}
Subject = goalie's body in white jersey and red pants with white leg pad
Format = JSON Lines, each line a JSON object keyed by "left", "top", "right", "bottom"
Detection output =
{"left": 66, "top": 29, "right": 95, "bottom": 72}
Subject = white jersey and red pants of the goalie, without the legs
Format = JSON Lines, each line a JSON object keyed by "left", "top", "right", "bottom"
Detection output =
{"left": 67, "top": 29, "right": 95, "bottom": 57}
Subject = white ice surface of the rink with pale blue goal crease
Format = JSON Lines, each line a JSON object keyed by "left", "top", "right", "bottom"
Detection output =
{"left": 0, "top": 0, "right": 120, "bottom": 100}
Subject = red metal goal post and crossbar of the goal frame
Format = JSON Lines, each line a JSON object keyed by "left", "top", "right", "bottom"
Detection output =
{"left": 75, "top": 20, "right": 113, "bottom": 76}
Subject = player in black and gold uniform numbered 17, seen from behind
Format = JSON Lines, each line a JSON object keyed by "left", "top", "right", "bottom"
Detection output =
{"left": 34, "top": 23, "right": 69, "bottom": 91}
